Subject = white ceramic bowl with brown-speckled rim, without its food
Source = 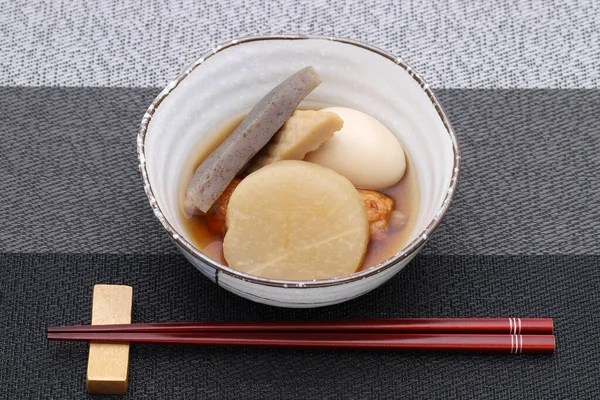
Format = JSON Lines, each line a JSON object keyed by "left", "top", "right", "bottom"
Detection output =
{"left": 137, "top": 35, "right": 460, "bottom": 308}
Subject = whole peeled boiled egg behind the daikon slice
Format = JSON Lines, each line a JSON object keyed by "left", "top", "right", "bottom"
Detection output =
{"left": 305, "top": 107, "right": 406, "bottom": 189}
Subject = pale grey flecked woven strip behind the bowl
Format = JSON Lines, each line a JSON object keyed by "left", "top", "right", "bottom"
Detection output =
{"left": 0, "top": 0, "right": 600, "bottom": 89}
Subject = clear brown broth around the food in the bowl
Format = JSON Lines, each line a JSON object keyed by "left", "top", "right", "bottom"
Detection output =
{"left": 179, "top": 115, "right": 419, "bottom": 271}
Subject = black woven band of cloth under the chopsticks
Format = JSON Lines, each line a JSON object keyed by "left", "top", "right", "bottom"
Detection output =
{"left": 0, "top": 254, "right": 600, "bottom": 399}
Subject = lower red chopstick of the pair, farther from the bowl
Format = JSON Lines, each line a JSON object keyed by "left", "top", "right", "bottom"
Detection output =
{"left": 48, "top": 332, "right": 555, "bottom": 354}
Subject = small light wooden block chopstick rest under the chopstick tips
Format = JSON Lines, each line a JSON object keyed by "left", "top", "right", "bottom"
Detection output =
{"left": 86, "top": 285, "right": 133, "bottom": 394}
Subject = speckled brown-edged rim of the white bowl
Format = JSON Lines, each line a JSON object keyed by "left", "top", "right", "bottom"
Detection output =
{"left": 137, "top": 34, "right": 461, "bottom": 289}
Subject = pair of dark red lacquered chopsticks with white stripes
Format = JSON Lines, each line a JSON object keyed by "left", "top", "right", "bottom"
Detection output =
{"left": 47, "top": 318, "right": 555, "bottom": 354}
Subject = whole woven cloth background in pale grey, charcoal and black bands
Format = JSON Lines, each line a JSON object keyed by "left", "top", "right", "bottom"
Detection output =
{"left": 0, "top": 0, "right": 600, "bottom": 399}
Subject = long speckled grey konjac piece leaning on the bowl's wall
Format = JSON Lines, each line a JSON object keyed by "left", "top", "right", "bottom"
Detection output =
{"left": 184, "top": 67, "right": 321, "bottom": 215}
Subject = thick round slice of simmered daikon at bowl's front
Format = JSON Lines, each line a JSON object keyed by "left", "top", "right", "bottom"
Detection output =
{"left": 223, "top": 161, "right": 369, "bottom": 280}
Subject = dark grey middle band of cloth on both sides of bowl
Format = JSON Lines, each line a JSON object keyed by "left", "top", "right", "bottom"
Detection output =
{"left": 0, "top": 87, "right": 600, "bottom": 255}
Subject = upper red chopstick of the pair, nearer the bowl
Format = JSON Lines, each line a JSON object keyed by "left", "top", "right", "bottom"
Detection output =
{"left": 48, "top": 318, "right": 553, "bottom": 335}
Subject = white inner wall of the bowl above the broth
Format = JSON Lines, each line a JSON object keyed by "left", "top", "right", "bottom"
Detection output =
{"left": 144, "top": 39, "right": 455, "bottom": 276}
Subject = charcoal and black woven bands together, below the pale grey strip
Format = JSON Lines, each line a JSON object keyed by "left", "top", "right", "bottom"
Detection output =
{"left": 0, "top": 87, "right": 600, "bottom": 399}
